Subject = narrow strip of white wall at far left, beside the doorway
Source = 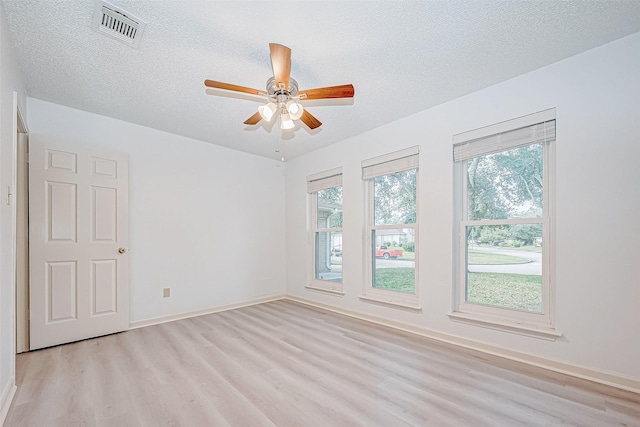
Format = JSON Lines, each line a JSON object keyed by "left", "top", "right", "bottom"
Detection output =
{"left": 0, "top": 0, "right": 26, "bottom": 414}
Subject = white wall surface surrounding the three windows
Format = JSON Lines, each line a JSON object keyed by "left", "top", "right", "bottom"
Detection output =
{"left": 286, "top": 33, "right": 640, "bottom": 381}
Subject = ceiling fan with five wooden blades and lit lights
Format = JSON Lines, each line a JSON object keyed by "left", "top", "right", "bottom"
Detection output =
{"left": 204, "top": 43, "right": 354, "bottom": 129}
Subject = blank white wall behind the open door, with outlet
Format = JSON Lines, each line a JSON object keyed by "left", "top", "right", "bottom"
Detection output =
{"left": 27, "top": 98, "right": 285, "bottom": 321}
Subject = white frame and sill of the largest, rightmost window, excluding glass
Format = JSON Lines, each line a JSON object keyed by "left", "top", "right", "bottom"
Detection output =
{"left": 449, "top": 109, "right": 562, "bottom": 340}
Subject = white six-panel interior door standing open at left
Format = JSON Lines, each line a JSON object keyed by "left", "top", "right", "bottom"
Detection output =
{"left": 29, "top": 140, "right": 129, "bottom": 350}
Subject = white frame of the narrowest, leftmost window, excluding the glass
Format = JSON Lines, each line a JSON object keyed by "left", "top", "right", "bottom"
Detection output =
{"left": 305, "top": 167, "right": 344, "bottom": 295}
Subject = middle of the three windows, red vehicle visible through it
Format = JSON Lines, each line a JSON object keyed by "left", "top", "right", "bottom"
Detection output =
{"left": 362, "top": 147, "right": 419, "bottom": 308}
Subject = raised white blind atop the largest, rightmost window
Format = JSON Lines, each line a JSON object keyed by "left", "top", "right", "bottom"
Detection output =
{"left": 453, "top": 120, "right": 556, "bottom": 162}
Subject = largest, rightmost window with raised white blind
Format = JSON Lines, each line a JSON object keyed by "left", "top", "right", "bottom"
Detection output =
{"left": 453, "top": 110, "right": 557, "bottom": 335}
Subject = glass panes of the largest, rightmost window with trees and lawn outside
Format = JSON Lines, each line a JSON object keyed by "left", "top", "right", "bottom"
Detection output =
{"left": 465, "top": 144, "right": 543, "bottom": 313}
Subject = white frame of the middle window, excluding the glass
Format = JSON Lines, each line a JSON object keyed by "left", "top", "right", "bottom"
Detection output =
{"left": 360, "top": 146, "right": 422, "bottom": 311}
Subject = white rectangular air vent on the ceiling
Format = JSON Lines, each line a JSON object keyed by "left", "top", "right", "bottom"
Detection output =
{"left": 91, "top": 1, "right": 147, "bottom": 48}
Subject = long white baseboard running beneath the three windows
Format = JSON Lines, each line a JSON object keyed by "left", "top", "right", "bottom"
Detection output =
{"left": 284, "top": 295, "right": 640, "bottom": 394}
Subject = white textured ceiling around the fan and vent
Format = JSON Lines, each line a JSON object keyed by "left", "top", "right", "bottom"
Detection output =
{"left": 1, "top": 0, "right": 640, "bottom": 158}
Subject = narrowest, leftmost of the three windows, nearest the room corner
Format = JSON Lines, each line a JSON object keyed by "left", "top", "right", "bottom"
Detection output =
{"left": 307, "top": 168, "right": 342, "bottom": 293}
